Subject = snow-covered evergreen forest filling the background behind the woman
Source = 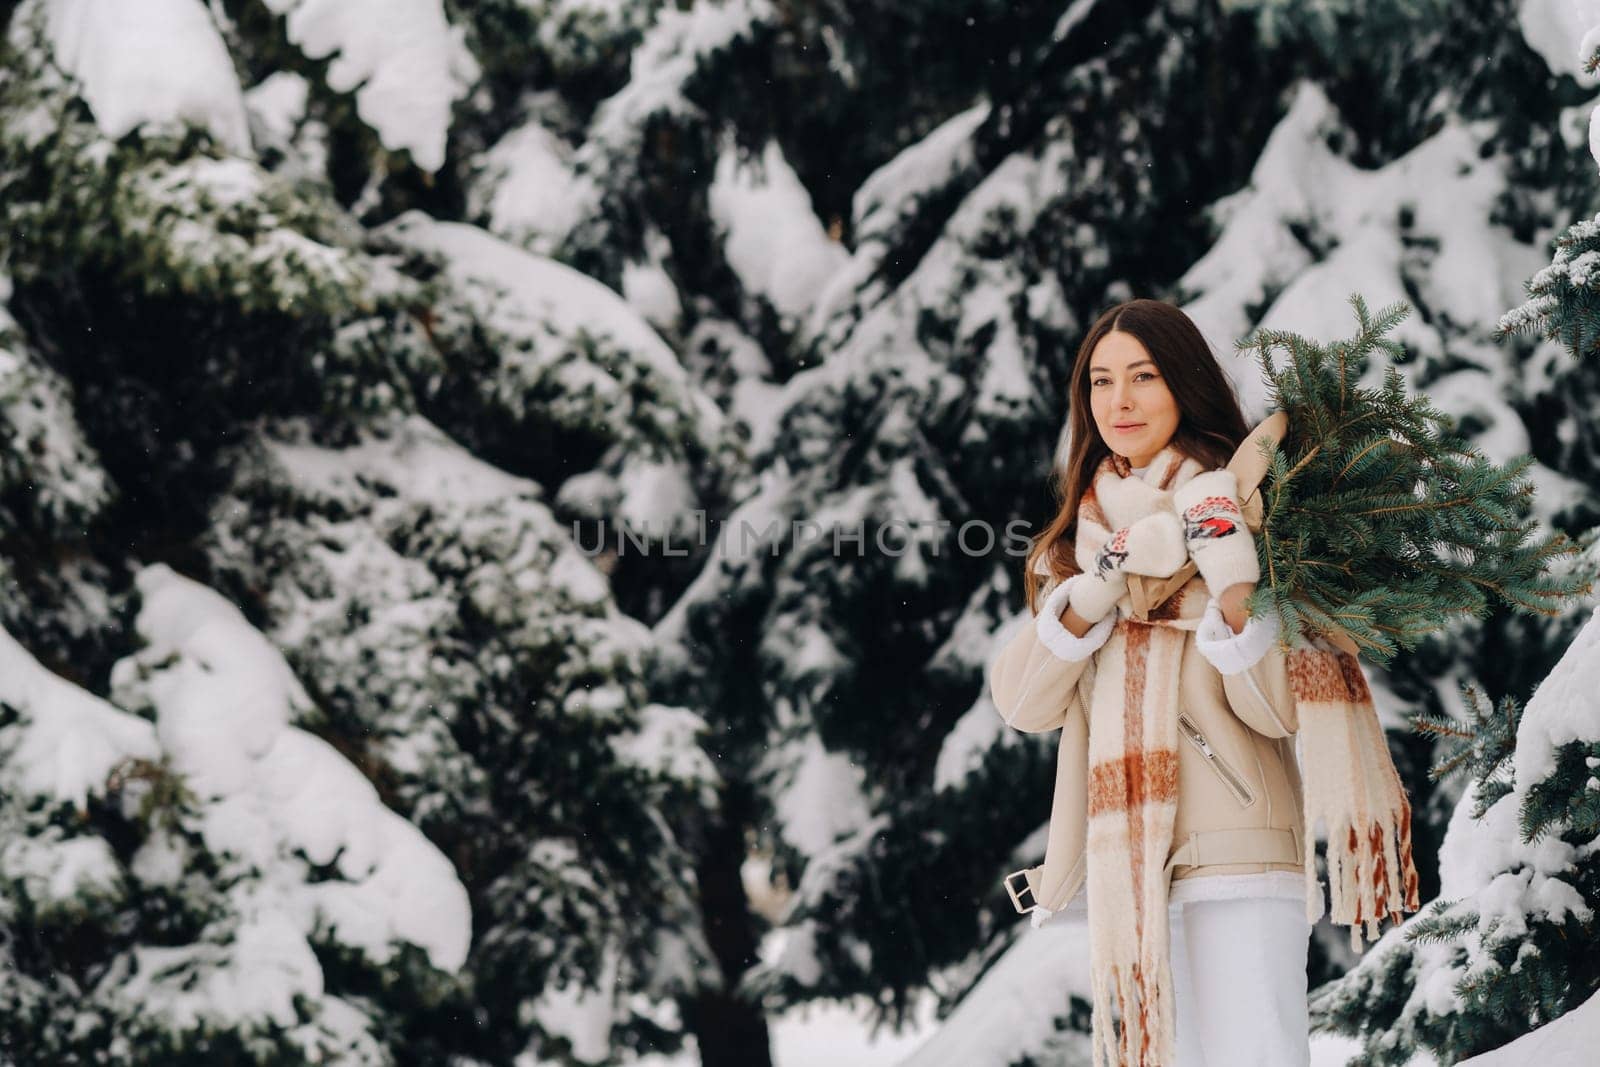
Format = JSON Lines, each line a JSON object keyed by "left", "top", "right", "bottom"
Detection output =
{"left": 0, "top": 0, "right": 1600, "bottom": 1067}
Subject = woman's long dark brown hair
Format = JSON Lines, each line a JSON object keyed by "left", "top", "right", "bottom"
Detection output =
{"left": 1022, "top": 299, "right": 1250, "bottom": 611}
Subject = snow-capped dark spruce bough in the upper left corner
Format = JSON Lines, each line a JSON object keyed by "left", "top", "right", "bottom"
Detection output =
{"left": 0, "top": 3, "right": 440, "bottom": 518}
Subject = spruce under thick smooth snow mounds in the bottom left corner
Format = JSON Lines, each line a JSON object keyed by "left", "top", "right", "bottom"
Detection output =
{"left": 0, "top": 565, "right": 472, "bottom": 1067}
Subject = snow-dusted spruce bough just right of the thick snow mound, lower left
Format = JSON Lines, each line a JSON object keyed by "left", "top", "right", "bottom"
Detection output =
{"left": 205, "top": 416, "right": 717, "bottom": 1062}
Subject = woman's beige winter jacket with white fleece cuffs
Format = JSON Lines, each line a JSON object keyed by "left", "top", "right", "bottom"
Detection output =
{"left": 990, "top": 577, "right": 1304, "bottom": 912}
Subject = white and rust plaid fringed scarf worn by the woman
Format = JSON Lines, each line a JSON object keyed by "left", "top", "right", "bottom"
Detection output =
{"left": 1074, "top": 446, "right": 1418, "bottom": 1067}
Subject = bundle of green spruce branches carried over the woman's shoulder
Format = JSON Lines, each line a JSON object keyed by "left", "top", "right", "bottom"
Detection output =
{"left": 1238, "top": 294, "right": 1590, "bottom": 662}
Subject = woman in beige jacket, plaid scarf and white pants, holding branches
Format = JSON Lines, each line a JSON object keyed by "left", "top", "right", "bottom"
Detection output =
{"left": 990, "top": 299, "right": 1320, "bottom": 1067}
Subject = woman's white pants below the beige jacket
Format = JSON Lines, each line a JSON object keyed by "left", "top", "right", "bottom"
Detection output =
{"left": 1168, "top": 899, "right": 1310, "bottom": 1067}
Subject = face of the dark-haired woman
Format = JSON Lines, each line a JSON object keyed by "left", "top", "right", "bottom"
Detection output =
{"left": 1090, "top": 330, "right": 1179, "bottom": 467}
